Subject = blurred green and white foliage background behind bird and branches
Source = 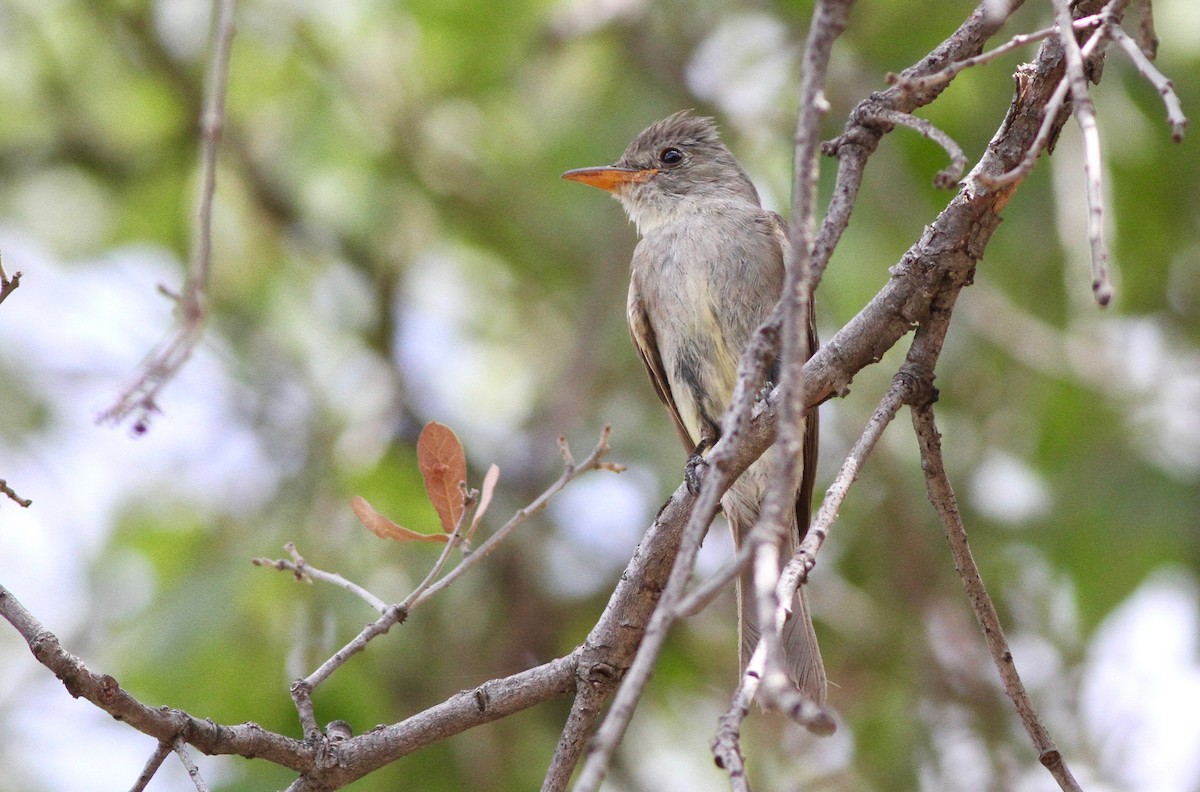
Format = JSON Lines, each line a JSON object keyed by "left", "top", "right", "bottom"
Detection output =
{"left": 0, "top": 0, "right": 1200, "bottom": 792}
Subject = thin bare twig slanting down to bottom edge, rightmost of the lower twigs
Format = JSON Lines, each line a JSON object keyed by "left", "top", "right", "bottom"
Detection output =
{"left": 912, "top": 403, "right": 1081, "bottom": 792}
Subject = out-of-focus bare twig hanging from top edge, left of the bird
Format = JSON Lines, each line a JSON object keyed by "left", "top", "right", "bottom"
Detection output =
{"left": 100, "top": 0, "right": 234, "bottom": 432}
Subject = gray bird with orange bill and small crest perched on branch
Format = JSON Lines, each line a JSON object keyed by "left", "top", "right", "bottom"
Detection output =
{"left": 563, "top": 112, "right": 826, "bottom": 704}
